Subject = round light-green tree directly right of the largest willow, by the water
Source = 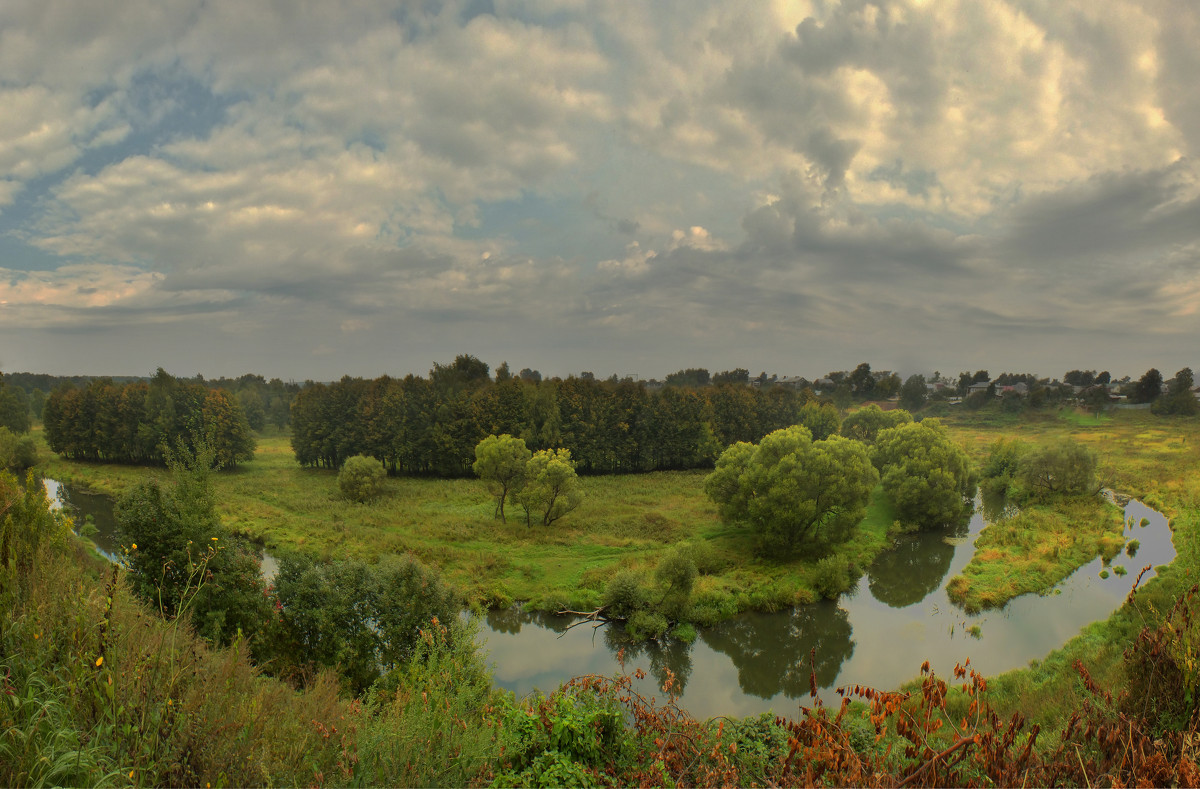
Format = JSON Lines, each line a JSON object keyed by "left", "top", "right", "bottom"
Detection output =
{"left": 872, "top": 420, "right": 976, "bottom": 528}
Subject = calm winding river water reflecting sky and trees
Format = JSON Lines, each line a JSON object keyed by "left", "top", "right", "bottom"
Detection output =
{"left": 47, "top": 480, "right": 1175, "bottom": 717}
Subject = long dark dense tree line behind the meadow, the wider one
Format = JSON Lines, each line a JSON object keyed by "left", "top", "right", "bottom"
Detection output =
{"left": 292, "top": 356, "right": 839, "bottom": 476}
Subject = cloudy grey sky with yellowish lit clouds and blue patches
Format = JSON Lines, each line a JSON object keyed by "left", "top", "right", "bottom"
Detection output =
{"left": 0, "top": 0, "right": 1200, "bottom": 380}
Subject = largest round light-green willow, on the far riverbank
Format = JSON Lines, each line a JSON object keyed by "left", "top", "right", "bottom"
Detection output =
{"left": 704, "top": 426, "right": 878, "bottom": 554}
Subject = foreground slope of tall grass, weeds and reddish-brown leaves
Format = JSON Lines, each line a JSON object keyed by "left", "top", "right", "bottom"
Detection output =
{"left": 7, "top": 446, "right": 1200, "bottom": 787}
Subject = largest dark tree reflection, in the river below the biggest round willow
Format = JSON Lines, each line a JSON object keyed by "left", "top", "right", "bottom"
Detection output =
{"left": 701, "top": 601, "right": 854, "bottom": 699}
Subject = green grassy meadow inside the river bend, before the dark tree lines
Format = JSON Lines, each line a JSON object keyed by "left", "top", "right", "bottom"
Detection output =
{"left": 32, "top": 435, "right": 894, "bottom": 622}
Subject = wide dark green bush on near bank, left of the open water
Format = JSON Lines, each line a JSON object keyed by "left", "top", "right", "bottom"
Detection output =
{"left": 275, "top": 555, "right": 458, "bottom": 691}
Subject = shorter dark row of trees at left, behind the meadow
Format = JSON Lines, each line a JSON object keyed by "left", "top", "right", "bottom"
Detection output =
{"left": 42, "top": 368, "right": 254, "bottom": 468}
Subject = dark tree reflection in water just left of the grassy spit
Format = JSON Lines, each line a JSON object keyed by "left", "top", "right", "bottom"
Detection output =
{"left": 869, "top": 524, "right": 967, "bottom": 608}
